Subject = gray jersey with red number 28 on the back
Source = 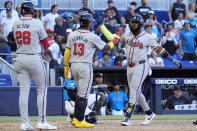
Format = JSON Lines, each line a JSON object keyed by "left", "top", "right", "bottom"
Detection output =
{"left": 13, "top": 17, "right": 47, "bottom": 54}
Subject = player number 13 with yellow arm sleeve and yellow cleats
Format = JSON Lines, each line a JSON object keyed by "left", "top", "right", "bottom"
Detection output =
{"left": 64, "top": 13, "right": 118, "bottom": 128}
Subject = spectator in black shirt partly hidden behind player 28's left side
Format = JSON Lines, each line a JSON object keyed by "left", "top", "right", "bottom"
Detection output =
{"left": 7, "top": 31, "right": 17, "bottom": 64}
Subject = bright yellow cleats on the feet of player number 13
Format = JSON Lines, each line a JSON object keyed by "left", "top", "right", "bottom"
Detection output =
{"left": 72, "top": 118, "right": 94, "bottom": 128}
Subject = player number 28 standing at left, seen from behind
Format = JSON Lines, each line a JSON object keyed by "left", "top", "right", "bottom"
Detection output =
{"left": 13, "top": 2, "right": 57, "bottom": 130}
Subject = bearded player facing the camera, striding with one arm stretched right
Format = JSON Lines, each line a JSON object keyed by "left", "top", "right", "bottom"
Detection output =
{"left": 101, "top": 14, "right": 182, "bottom": 126}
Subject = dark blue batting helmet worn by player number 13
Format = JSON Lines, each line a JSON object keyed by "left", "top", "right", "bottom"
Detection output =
{"left": 79, "top": 13, "right": 93, "bottom": 27}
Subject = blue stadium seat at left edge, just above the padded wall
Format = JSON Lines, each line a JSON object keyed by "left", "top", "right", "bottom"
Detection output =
{"left": 0, "top": 73, "right": 12, "bottom": 86}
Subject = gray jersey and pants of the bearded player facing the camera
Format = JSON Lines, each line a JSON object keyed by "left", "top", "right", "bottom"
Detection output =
{"left": 120, "top": 32, "right": 159, "bottom": 111}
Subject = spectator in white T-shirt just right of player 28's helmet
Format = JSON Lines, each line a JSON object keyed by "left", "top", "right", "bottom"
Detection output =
{"left": 44, "top": 5, "right": 65, "bottom": 30}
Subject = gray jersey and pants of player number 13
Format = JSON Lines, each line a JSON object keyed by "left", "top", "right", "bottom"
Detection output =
{"left": 67, "top": 30, "right": 106, "bottom": 99}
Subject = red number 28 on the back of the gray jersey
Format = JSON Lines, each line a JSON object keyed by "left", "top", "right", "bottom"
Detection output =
{"left": 16, "top": 31, "right": 31, "bottom": 45}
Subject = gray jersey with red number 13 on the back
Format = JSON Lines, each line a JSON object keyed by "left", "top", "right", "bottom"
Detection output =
{"left": 66, "top": 30, "right": 106, "bottom": 63}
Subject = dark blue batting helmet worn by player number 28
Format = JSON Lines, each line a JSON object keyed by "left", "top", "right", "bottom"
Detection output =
{"left": 21, "top": 1, "right": 36, "bottom": 15}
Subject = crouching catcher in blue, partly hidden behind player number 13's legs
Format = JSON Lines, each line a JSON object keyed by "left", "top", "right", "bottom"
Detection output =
{"left": 64, "top": 80, "right": 105, "bottom": 124}
